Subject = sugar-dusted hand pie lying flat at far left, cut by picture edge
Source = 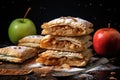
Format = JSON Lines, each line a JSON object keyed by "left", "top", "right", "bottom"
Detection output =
{"left": 0, "top": 46, "right": 37, "bottom": 63}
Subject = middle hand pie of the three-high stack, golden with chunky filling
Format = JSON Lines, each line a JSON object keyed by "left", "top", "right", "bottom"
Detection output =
{"left": 40, "top": 35, "right": 92, "bottom": 52}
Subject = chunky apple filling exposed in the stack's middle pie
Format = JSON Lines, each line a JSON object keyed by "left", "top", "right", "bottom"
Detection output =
{"left": 41, "top": 38, "right": 82, "bottom": 51}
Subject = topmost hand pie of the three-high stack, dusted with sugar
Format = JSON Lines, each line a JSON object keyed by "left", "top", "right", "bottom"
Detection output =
{"left": 41, "top": 16, "right": 94, "bottom": 36}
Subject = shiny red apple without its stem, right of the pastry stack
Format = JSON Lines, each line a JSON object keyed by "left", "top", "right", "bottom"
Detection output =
{"left": 93, "top": 28, "right": 120, "bottom": 57}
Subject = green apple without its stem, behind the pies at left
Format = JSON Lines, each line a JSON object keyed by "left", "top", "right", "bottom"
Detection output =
{"left": 8, "top": 18, "right": 37, "bottom": 44}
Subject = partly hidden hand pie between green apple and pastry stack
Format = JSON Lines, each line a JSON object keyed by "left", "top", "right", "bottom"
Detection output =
{"left": 18, "top": 35, "right": 43, "bottom": 48}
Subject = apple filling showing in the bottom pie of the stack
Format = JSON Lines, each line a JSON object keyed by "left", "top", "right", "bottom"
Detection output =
{"left": 37, "top": 57, "right": 87, "bottom": 66}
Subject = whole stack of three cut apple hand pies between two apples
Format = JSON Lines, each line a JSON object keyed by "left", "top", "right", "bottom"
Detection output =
{"left": 36, "top": 16, "right": 94, "bottom": 68}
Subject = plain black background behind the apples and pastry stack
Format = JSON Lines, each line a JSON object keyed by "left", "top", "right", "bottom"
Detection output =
{"left": 0, "top": 0, "right": 120, "bottom": 44}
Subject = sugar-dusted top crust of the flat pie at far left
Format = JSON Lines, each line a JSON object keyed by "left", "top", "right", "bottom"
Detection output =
{"left": 0, "top": 46, "right": 37, "bottom": 57}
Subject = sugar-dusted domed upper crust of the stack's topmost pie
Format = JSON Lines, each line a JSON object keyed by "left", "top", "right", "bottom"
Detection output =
{"left": 41, "top": 16, "right": 93, "bottom": 28}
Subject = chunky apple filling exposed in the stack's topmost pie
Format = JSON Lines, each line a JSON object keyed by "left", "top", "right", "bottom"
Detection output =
{"left": 42, "top": 25, "right": 86, "bottom": 36}
